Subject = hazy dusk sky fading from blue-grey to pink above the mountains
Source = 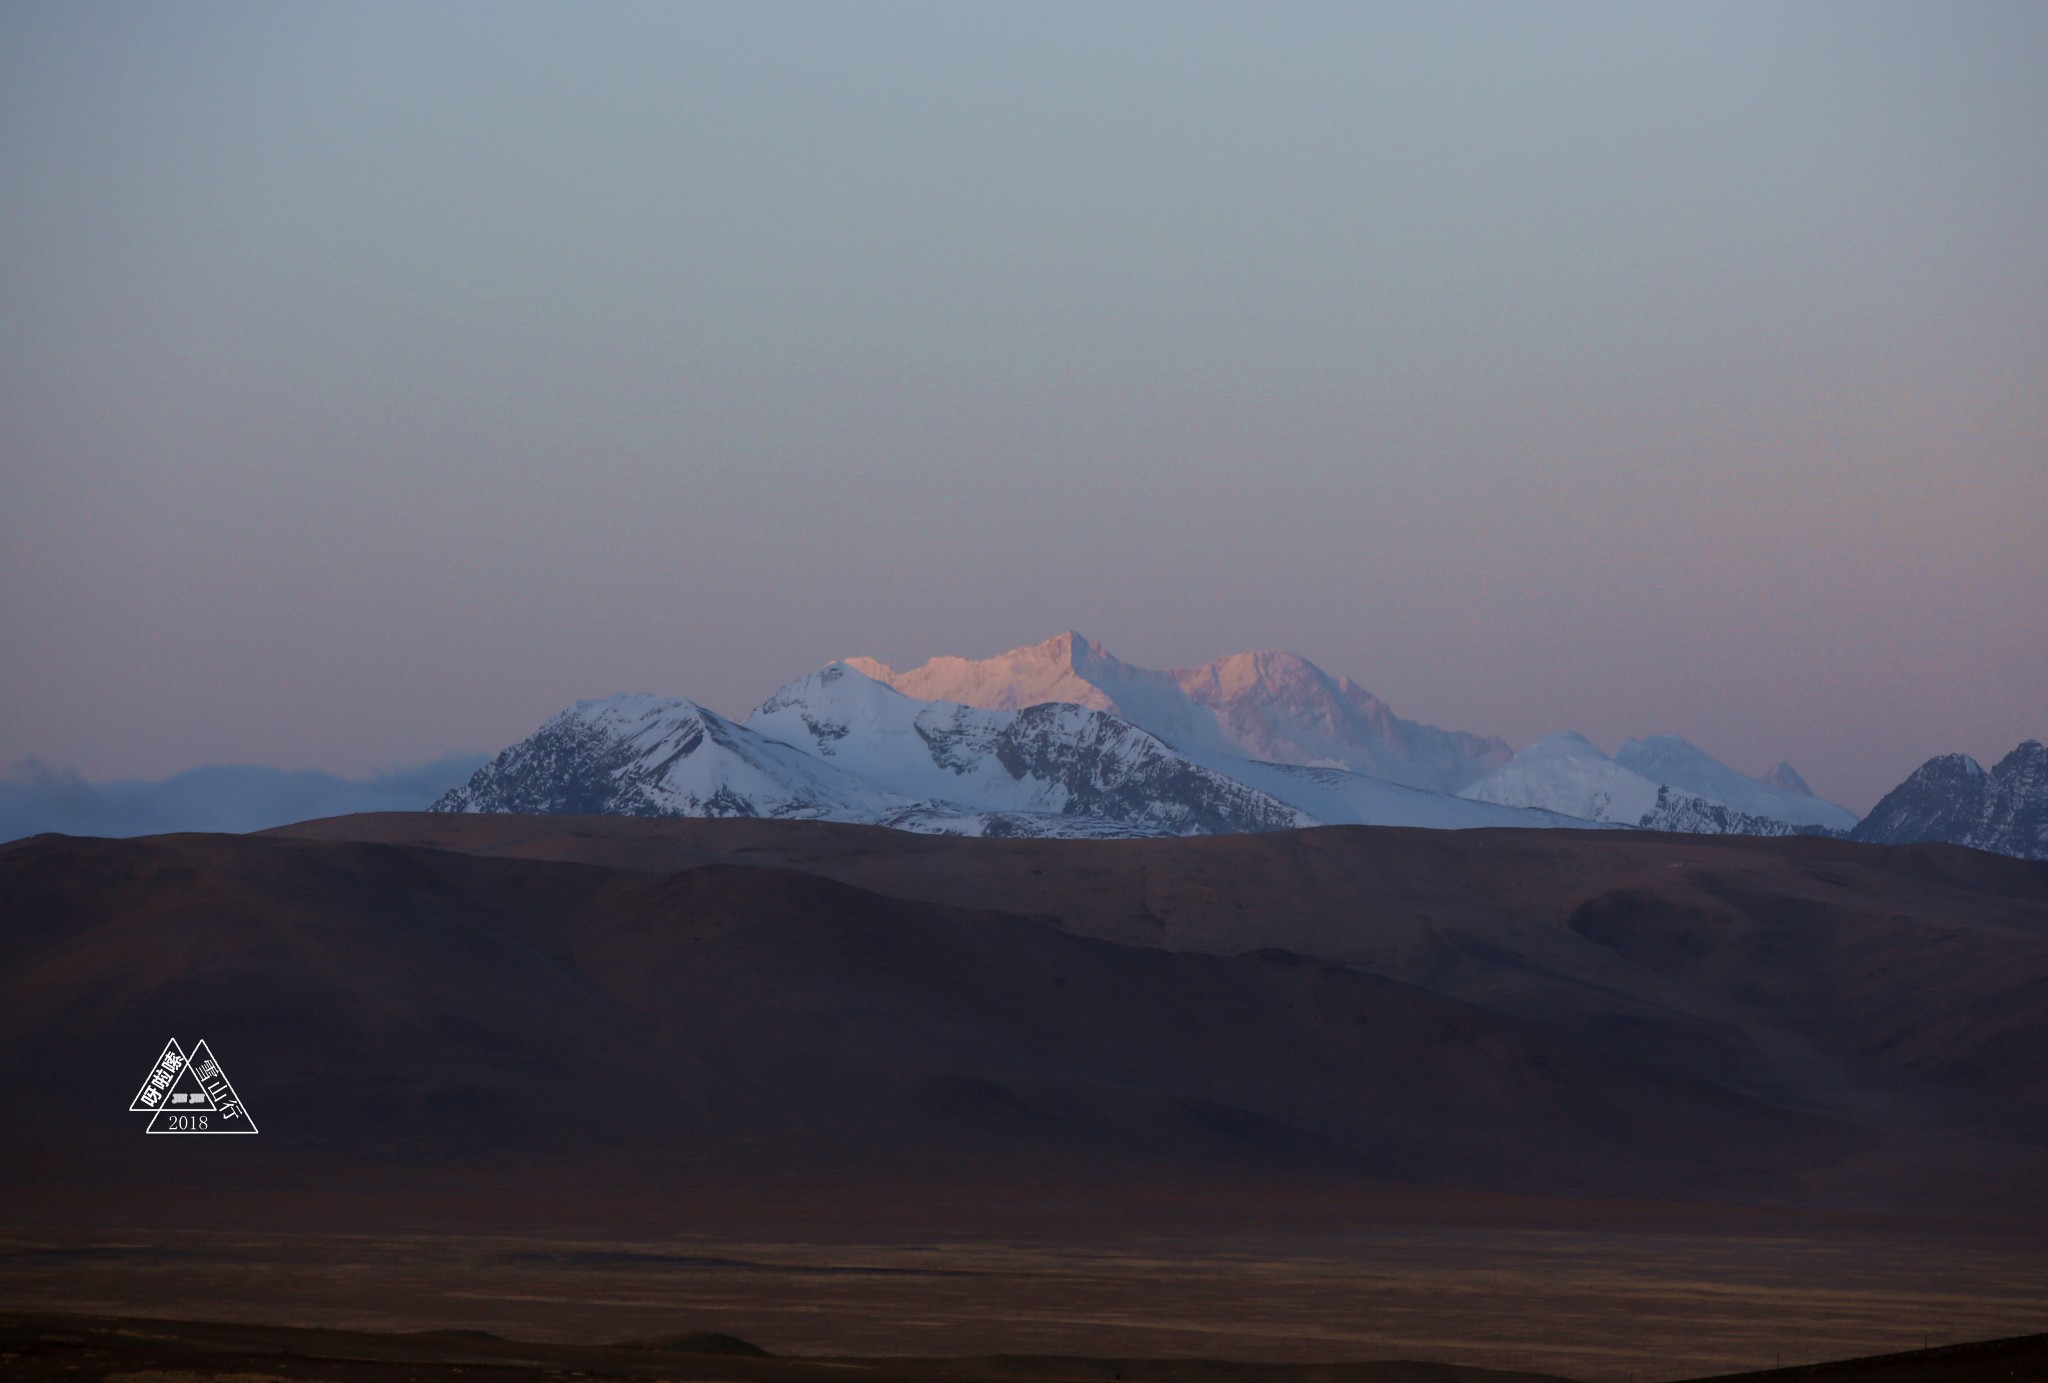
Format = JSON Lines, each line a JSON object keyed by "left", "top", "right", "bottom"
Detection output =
{"left": 0, "top": 0, "right": 2048, "bottom": 809}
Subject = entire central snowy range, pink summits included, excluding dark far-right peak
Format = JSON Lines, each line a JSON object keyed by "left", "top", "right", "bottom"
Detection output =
{"left": 434, "top": 631, "right": 1900, "bottom": 836}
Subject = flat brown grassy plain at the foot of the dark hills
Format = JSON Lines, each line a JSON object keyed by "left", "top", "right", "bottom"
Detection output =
{"left": 0, "top": 1201, "right": 2048, "bottom": 1379}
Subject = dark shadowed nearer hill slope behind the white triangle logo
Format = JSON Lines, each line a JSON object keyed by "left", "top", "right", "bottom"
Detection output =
{"left": 0, "top": 836, "right": 1868, "bottom": 1199}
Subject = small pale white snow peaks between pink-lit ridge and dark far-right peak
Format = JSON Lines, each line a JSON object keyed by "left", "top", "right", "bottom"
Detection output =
{"left": 1462, "top": 729, "right": 1855, "bottom": 836}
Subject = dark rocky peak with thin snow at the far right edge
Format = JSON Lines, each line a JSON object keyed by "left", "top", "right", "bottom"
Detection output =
{"left": 1849, "top": 740, "right": 2048, "bottom": 861}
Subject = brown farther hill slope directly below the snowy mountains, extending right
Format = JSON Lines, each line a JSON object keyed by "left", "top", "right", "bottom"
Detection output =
{"left": 220, "top": 815, "right": 2048, "bottom": 1211}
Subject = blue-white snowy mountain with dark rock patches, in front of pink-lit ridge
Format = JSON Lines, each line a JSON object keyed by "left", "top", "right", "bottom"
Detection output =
{"left": 434, "top": 664, "right": 1583, "bottom": 836}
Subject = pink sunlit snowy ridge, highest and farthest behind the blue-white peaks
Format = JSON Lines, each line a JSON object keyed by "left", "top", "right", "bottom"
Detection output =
{"left": 846, "top": 631, "right": 1509, "bottom": 793}
